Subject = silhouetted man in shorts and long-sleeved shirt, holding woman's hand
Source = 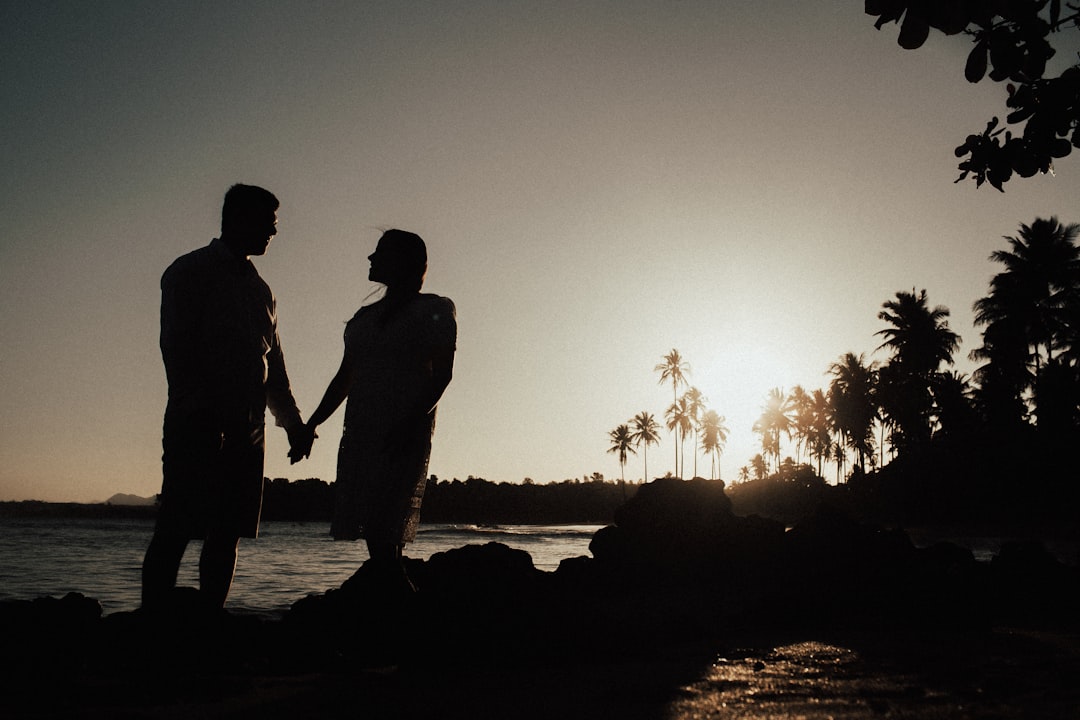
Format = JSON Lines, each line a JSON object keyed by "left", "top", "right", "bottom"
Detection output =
{"left": 143, "top": 185, "right": 312, "bottom": 608}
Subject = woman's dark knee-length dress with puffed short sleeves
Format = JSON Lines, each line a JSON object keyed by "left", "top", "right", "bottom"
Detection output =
{"left": 330, "top": 295, "right": 457, "bottom": 545}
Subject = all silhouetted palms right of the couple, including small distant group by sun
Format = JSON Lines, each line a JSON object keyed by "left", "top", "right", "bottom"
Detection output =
{"left": 609, "top": 217, "right": 1080, "bottom": 526}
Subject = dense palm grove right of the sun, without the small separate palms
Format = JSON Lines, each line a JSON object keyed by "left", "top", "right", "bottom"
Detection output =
{"left": 755, "top": 218, "right": 1080, "bottom": 474}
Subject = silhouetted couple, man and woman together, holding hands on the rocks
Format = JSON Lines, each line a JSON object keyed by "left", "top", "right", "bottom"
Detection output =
{"left": 143, "top": 185, "right": 457, "bottom": 609}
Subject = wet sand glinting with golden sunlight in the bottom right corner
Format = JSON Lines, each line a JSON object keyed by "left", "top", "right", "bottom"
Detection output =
{"left": 662, "top": 628, "right": 1080, "bottom": 720}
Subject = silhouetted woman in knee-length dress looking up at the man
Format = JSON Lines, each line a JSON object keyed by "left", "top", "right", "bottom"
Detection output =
{"left": 307, "top": 230, "right": 457, "bottom": 589}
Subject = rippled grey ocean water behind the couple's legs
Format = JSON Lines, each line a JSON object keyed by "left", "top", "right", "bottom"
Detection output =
{"left": 0, "top": 518, "right": 602, "bottom": 615}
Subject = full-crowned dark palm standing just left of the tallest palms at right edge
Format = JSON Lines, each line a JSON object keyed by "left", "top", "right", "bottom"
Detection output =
{"left": 876, "top": 288, "right": 960, "bottom": 448}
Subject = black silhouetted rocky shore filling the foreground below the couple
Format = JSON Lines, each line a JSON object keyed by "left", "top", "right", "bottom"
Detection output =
{"left": 0, "top": 480, "right": 1080, "bottom": 718}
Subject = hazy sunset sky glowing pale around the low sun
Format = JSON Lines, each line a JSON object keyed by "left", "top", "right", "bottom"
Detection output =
{"left": 0, "top": 0, "right": 1080, "bottom": 502}
